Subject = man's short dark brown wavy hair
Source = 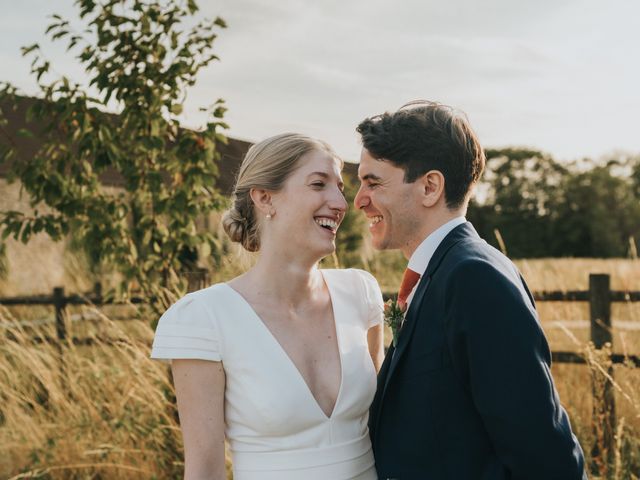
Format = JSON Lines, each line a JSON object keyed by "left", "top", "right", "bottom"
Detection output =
{"left": 356, "top": 100, "right": 485, "bottom": 208}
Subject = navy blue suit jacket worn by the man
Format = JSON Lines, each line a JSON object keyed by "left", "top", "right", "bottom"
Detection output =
{"left": 369, "top": 223, "right": 586, "bottom": 480}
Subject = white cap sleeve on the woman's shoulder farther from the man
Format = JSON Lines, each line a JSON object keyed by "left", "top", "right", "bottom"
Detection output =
{"left": 151, "top": 292, "right": 222, "bottom": 361}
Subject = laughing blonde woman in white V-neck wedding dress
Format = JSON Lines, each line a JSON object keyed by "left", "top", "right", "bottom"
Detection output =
{"left": 151, "top": 134, "right": 383, "bottom": 480}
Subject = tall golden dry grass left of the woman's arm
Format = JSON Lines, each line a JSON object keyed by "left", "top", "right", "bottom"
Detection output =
{"left": 0, "top": 309, "right": 182, "bottom": 479}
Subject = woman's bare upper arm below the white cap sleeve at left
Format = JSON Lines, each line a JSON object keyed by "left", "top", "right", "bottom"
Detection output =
{"left": 171, "top": 360, "right": 226, "bottom": 480}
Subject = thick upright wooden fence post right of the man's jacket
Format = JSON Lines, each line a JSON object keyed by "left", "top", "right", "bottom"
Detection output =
{"left": 589, "top": 273, "right": 616, "bottom": 474}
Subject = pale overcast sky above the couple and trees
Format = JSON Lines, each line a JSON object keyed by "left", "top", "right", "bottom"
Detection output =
{"left": 0, "top": 0, "right": 640, "bottom": 160}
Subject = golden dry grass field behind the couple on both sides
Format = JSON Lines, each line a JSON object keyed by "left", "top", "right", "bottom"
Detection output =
{"left": 0, "top": 254, "right": 640, "bottom": 479}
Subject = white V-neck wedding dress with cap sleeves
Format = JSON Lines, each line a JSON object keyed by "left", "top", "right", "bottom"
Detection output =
{"left": 151, "top": 269, "right": 383, "bottom": 480}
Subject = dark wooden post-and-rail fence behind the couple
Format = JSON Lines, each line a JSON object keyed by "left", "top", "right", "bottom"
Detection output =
{"left": 0, "top": 274, "right": 640, "bottom": 468}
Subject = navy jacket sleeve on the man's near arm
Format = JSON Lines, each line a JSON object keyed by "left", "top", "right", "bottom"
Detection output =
{"left": 446, "top": 259, "right": 586, "bottom": 480}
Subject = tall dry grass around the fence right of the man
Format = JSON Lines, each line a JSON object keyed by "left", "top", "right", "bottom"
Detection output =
{"left": 516, "top": 259, "right": 640, "bottom": 480}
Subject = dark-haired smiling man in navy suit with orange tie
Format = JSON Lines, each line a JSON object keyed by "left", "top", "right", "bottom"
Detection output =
{"left": 355, "top": 102, "right": 586, "bottom": 480}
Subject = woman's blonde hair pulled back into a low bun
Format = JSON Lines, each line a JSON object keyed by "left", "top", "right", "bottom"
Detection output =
{"left": 222, "top": 133, "right": 342, "bottom": 252}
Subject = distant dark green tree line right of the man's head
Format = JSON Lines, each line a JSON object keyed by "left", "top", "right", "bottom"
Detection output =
{"left": 467, "top": 148, "right": 640, "bottom": 258}
